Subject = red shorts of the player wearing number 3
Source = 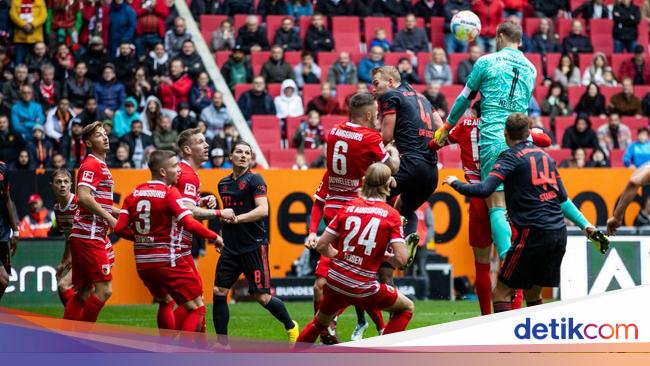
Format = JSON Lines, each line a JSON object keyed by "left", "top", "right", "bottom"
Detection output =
{"left": 138, "top": 257, "right": 203, "bottom": 306}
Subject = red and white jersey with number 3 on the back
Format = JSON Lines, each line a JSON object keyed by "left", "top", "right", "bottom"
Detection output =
{"left": 120, "top": 181, "right": 192, "bottom": 269}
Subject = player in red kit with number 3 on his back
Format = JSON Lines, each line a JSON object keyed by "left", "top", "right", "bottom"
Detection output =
{"left": 115, "top": 150, "right": 223, "bottom": 332}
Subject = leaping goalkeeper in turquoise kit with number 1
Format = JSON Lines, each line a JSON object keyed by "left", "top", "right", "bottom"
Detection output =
{"left": 437, "top": 22, "right": 537, "bottom": 258}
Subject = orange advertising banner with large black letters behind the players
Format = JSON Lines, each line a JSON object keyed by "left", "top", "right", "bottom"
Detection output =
{"left": 105, "top": 169, "right": 640, "bottom": 304}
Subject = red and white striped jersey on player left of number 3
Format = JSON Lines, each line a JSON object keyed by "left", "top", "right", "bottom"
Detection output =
{"left": 70, "top": 154, "right": 113, "bottom": 241}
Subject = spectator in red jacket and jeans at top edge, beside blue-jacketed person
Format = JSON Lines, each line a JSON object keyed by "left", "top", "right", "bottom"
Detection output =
{"left": 131, "top": 0, "right": 169, "bottom": 58}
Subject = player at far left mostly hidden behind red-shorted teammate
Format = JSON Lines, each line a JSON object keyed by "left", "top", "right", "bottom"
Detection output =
{"left": 50, "top": 169, "right": 78, "bottom": 306}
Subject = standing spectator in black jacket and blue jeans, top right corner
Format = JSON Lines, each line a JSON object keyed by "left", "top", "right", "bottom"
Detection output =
{"left": 612, "top": 0, "right": 641, "bottom": 53}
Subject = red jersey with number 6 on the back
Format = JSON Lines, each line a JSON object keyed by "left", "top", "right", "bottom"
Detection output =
{"left": 316, "top": 122, "right": 390, "bottom": 208}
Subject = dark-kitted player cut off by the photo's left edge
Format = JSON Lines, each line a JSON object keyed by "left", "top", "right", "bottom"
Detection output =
{"left": 0, "top": 161, "right": 18, "bottom": 299}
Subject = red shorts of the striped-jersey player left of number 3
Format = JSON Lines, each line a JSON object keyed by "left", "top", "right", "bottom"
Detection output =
{"left": 68, "top": 237, "right": 115, "bottom": 288}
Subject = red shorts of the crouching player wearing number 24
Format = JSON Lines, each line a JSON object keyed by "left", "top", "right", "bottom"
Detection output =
{"left": 319, "top": 283, "right": 397, "bottom": 314}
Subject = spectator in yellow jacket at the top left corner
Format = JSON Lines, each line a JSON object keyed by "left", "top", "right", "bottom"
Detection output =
{"left": 9, "top": 0, "right": 47, "bottom": 64}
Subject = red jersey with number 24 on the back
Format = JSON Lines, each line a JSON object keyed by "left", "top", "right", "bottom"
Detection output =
{"left": 326, "top": 198, "right": 404, "bottom": 297}
